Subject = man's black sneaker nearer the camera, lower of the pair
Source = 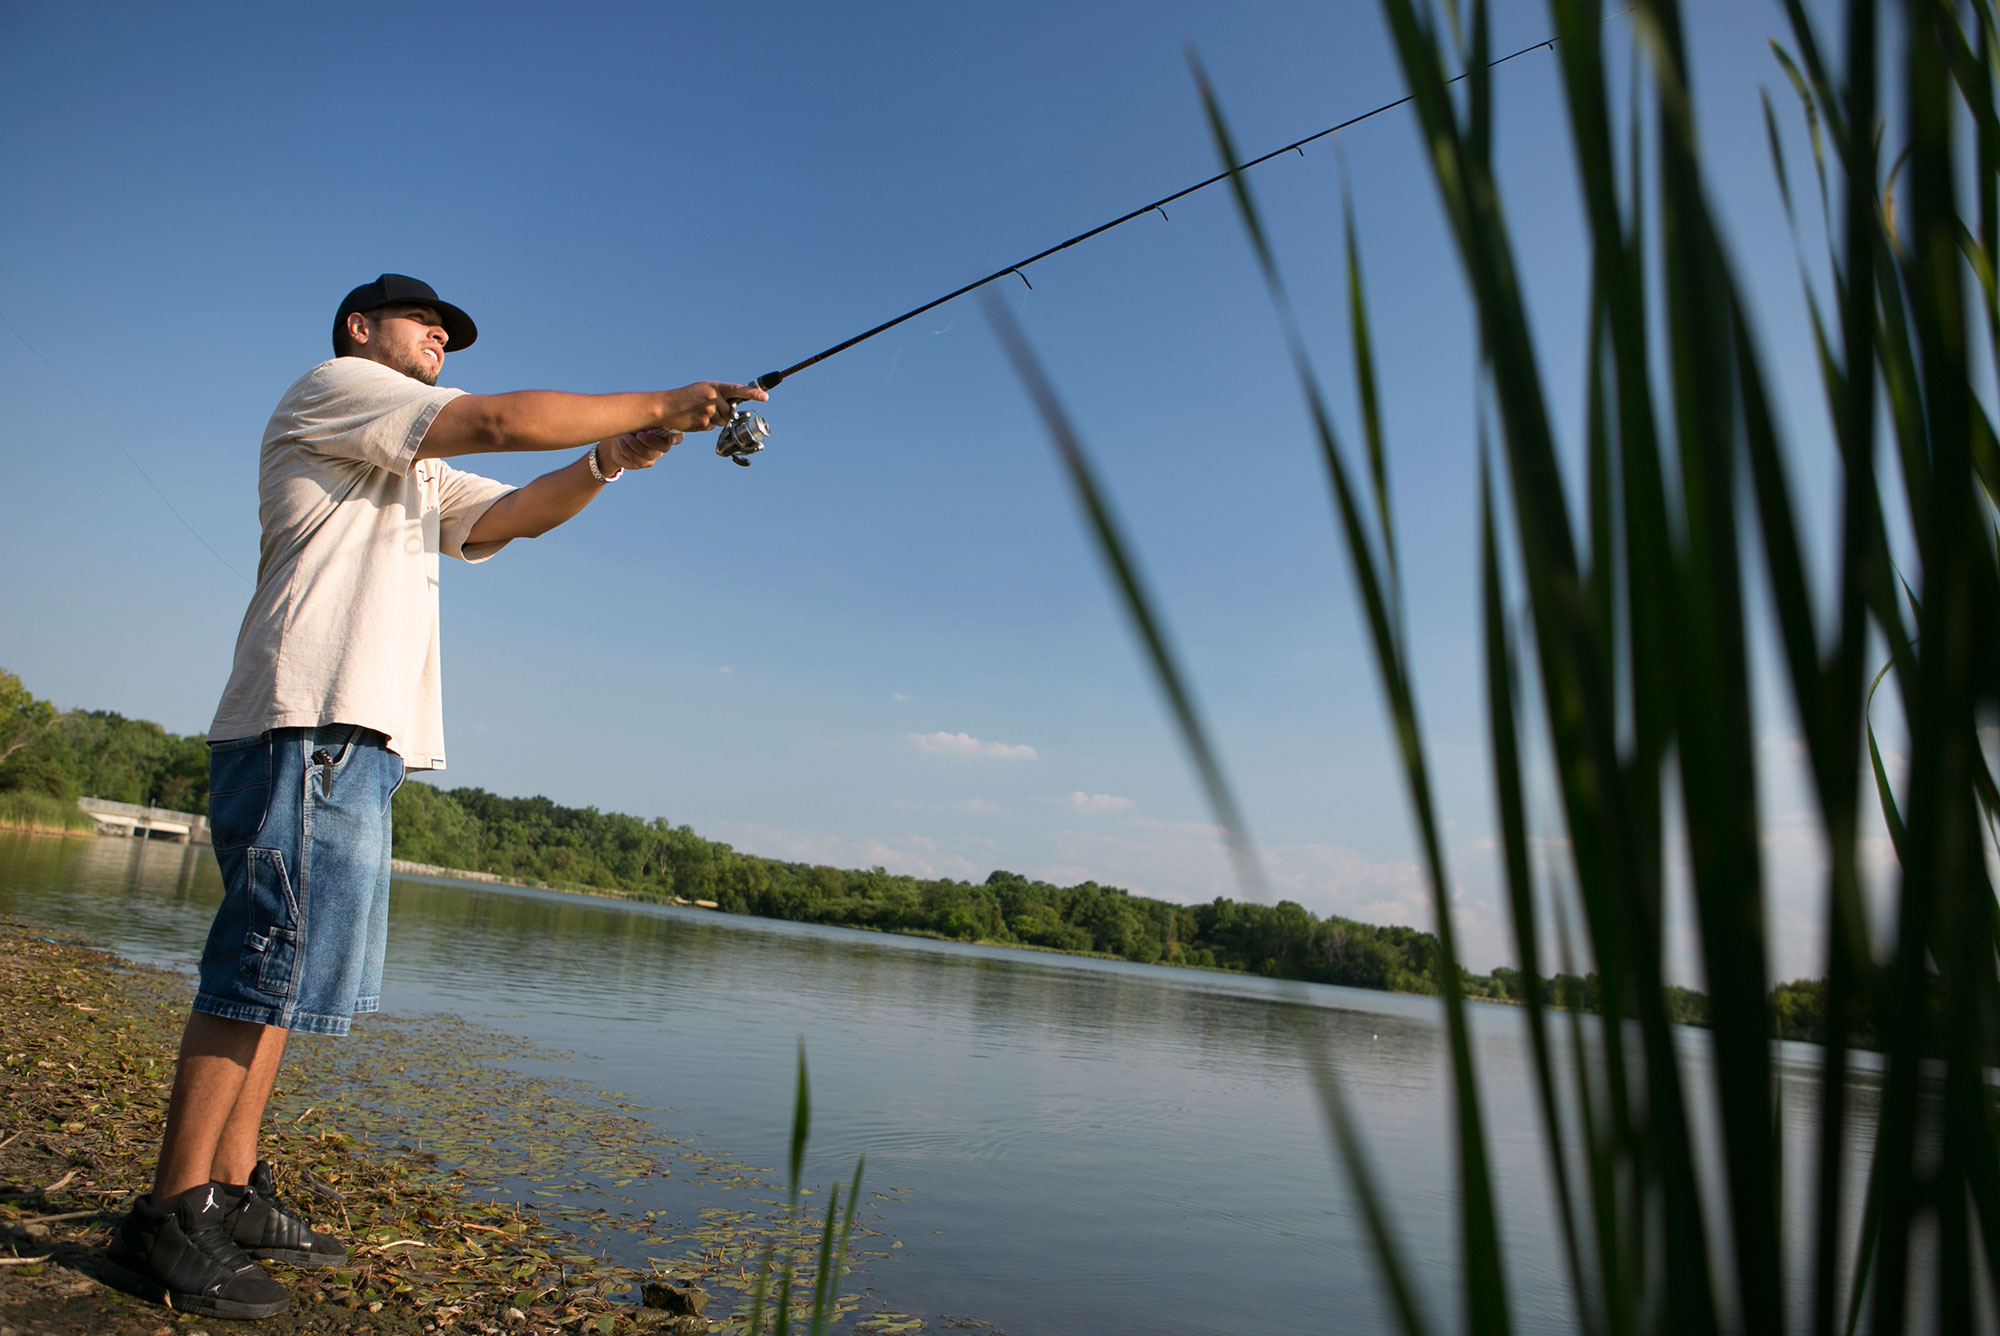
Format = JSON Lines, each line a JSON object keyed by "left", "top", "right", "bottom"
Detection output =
{"left": 106, "top": 1184, "right": 292, "bottom": 1318}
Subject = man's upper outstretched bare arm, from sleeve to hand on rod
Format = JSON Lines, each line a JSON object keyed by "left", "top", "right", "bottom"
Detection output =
{"left": 416, "top": 380, "right": 770, "bottom": 460}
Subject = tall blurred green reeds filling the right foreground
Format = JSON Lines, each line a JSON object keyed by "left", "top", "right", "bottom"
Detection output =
{"left": 992, "top": 0, "right": 2000, "bottom": 1336}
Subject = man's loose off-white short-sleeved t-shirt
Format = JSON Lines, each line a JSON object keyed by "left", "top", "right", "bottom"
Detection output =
{"left": 208, "top": 358, "right": 514, "bottom": 770}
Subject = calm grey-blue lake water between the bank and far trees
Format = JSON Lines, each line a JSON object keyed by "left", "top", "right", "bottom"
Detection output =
{"left": 0, "top": 832, "right": 1896, "bottom": 1336}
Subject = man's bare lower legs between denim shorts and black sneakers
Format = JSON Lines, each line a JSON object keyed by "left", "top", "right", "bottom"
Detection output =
{"left": 152, "top": 1012, "right": 286, "bottom": 1204}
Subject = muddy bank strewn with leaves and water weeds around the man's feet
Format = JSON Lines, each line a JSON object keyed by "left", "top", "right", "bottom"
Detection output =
{"left": 0, "top": 918, "right": 756, "bottom": 1336}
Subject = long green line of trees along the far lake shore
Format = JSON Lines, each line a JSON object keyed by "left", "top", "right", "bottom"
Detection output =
{"left": 0, "top": 670, "right": 1864, "bottom": 1042}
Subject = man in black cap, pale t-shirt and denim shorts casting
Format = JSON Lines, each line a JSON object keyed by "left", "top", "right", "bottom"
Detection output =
{"left": 110, "top": 274, "right": 768, "bottom": 1318}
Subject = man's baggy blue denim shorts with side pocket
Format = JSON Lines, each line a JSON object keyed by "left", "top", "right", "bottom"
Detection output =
{"left": 194, "top": 724, "right": 402, "bottom": 1034}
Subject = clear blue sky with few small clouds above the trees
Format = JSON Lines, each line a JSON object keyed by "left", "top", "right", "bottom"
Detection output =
{"left": 0, "top": 0, "right": 1872, "bottom": 974}
